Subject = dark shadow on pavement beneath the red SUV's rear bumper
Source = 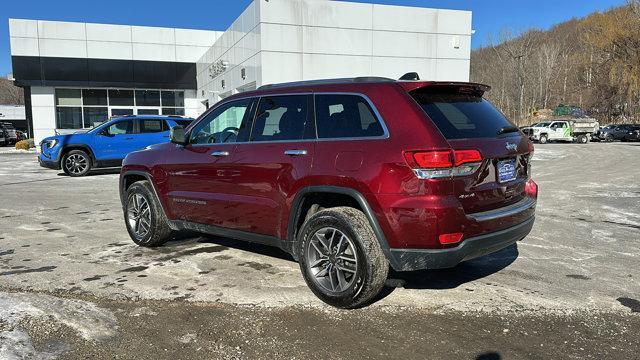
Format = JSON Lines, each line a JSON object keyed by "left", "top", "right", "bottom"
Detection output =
{"left": 389, "top": 244, "right": 518, "bottom": 290}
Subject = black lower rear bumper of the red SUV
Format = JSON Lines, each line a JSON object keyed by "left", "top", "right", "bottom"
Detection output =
{"left": 390, "top": 217, "right": 535, "bottom": 271}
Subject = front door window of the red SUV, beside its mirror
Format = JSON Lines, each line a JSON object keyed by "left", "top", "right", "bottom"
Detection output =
{"left": 190, "top": 99, "right": 251, "bottom": 144}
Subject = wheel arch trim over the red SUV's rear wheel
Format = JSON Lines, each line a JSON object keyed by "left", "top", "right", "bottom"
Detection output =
{"left": 285, "top": 186, "right": 396, "bottom": 268}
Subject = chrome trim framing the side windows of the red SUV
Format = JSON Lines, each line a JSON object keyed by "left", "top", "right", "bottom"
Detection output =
{"left": 189, "top": 91, "right": 391, "bottom": 147}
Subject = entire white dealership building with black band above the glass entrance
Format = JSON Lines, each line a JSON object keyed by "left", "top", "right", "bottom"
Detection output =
{"left": 9, "top": 0, "right": 472, "bottom": 142}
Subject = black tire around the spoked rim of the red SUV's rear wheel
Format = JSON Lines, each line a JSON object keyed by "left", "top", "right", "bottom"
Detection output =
{"left": 297, "top": 207, "right": 389, "bottom": 309}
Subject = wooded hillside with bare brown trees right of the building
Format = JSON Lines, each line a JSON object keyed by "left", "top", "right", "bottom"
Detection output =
{"left": 471, "top": 0, "right": 640, "bottom": 124}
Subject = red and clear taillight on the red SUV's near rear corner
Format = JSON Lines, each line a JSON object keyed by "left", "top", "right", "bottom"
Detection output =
{"left": 404, "top": 150, "right": 482, "bottom": 179}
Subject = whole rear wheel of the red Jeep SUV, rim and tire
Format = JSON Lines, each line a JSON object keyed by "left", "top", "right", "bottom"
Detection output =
{"left": 298, "top": 207, "right": 389, "bottom": 309}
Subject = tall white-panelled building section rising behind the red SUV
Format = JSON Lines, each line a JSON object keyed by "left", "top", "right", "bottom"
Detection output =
{"left": 197, "top": 0, "right": 472, "bottom": 103}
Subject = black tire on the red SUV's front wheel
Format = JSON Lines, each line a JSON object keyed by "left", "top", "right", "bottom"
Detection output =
{"left": 124, "top": 180, "right": 172, "bottom": 247}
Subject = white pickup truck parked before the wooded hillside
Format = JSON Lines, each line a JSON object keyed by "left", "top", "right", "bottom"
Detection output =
{"left": 522, "top": 118, "right": 600, "bottom": 144}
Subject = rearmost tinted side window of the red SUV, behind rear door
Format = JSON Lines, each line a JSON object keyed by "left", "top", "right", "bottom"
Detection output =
{"left": 316, "top": 95, "right": 384, "bottom": 139}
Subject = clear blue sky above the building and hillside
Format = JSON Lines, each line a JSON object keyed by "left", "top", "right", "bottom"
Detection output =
{"left": 0, "top": 0, "right": 624, "bottom": 74}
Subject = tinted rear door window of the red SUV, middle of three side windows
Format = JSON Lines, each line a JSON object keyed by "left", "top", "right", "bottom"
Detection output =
{"left": 251, "top": 95, "right": 308, "bottom": 141}
